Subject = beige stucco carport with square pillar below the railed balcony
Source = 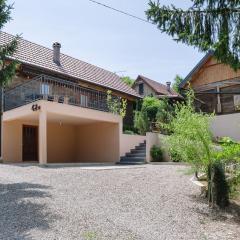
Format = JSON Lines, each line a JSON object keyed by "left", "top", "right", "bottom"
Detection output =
{"left": 2, "top": 101, "right": 122, "bottom": 164}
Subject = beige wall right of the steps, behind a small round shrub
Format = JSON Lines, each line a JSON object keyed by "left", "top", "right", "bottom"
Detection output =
{"left": 146, "top": 132, "right": 171, "bottom": 162}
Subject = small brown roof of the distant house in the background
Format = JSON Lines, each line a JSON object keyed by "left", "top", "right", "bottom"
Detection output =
{"left": 137, "top": 75, "right": 181, "bottom": 97}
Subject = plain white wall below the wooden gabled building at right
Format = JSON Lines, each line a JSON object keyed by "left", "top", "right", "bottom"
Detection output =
{"left": 211, "top": 113, "right": 240, "bottom": 141}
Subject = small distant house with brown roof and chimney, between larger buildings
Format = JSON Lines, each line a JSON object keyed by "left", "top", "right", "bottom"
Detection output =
{"left": 132, "top": 75, "right": 182, "bottom": 100}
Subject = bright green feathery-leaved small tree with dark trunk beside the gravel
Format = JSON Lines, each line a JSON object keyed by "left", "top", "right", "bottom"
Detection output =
{"left": 166, "top": 91, "right": 228, "bottom": 207}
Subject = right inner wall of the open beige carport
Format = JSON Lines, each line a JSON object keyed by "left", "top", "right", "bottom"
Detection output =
{"left": 77, "top": 122, "right": 120, "bottom": 163}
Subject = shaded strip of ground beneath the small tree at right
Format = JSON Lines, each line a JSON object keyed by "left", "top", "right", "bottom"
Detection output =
{"left": 190, "top": 196, "right": 240, "bottom": 224}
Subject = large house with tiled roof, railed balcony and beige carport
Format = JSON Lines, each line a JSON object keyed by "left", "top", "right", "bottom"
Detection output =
{"left": 0, "top": 32, "right": 140, "bottom": 164}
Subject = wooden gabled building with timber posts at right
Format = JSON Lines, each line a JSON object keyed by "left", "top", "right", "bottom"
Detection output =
{"left": 179, "top": 51, "right": 240, "bottom": 115}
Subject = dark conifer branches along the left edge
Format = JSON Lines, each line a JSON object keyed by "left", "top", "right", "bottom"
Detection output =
{"left": 0, "top": 0, "right": 19, "bottom": 87}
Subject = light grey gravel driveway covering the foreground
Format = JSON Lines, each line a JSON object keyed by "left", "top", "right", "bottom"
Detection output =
{"left": 0, "top": 164, "right": 240, "bottom": 240}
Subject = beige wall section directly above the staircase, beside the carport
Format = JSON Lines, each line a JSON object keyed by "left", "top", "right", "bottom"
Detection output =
{"left": 120, "top": 134, "right": 146, "bottom": 156}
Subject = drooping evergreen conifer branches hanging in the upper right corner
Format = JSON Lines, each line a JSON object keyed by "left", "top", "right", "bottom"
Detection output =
{"left": 146, "top": 0, "right": 240, "bottom": 70}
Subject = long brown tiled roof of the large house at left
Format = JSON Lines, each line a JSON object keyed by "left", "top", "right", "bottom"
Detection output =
{"left": 0, "top": 32, "right": 140, "bottom": 97}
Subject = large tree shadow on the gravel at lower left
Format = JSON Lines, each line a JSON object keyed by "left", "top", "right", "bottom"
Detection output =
{"left": 0, "top": 183, "right": 57, "bottom": 240}
